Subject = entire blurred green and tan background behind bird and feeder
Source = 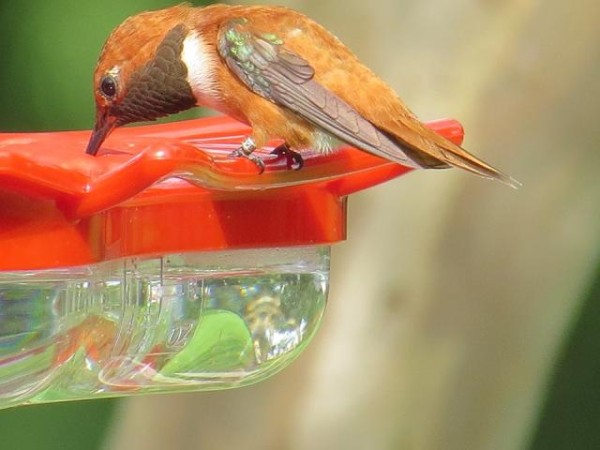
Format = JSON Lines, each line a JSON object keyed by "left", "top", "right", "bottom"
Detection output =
{"left": 0, "top": 0, "right": 600, "bottom": 450}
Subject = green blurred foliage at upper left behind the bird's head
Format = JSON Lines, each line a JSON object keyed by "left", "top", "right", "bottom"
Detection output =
{"left": 0, "top": 0, "right": 206, "bottom": 131}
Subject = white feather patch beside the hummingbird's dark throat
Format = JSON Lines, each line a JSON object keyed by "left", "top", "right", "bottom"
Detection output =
{"left": 181, "top": 32, "right": 221, "bottom": 109}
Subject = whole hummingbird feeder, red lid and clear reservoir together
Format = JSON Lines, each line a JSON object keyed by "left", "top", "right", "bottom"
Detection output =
{"left": 0, "top": 117, "right": 463, "bottom": 407}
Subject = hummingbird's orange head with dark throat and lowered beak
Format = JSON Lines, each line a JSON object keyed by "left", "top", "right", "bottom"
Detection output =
{"left": 86, "top": 6, "right": 196, "bottom": 155}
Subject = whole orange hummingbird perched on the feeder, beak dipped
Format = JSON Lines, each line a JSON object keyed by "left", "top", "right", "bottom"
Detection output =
{"left": 86, "top": 4, "right": 518, "bottom": 187}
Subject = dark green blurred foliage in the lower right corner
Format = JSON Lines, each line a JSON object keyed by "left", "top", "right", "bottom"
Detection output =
{"left": 530, "top": 255, "right": 600, "bottom": 450}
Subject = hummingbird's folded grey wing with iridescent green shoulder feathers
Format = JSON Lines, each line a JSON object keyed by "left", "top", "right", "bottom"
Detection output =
{"left": 217, "top": 18, "right": 421, "bottom": 167}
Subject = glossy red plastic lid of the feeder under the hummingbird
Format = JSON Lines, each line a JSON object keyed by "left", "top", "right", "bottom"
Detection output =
{"left": 0, "top": 117, "right": 463, "bottom": 271}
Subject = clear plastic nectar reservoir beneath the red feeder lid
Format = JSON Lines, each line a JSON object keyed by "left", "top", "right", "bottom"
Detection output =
{"left": 0, "top": 246, "right": 329, "bottom": 407}
